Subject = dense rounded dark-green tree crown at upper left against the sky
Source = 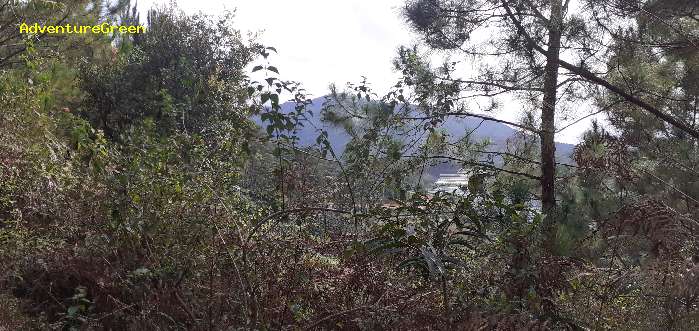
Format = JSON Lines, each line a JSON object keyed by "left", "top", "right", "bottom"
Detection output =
{"left": 81, "top": 8, "right": 253, "bottom": 140}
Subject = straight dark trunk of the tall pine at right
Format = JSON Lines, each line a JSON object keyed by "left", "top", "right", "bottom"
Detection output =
{"left": 540, "top": 0, "right": 563, "bottom": 253}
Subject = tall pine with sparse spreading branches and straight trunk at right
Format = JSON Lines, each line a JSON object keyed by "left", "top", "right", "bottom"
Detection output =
{"left": 398, "top": 0, "right": 699, "bottom": 249}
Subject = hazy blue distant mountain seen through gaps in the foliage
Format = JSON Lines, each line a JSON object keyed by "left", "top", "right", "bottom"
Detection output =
{"left": 254, "top": 97, "right": 574, "bottom": 180}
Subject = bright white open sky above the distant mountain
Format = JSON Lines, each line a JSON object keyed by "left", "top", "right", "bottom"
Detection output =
{"left": 138, "top": 0, "right": 590, "bottom": 143}
